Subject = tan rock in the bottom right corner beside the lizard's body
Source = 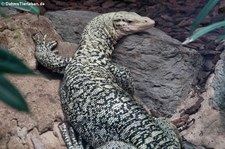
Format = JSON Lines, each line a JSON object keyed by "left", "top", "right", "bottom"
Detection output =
{"left": 173, "top": 85, "right": 225, "bottom": 149}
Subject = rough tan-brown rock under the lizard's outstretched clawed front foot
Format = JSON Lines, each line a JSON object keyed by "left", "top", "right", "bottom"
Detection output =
{"left": 0, "top": 14, "right": 67, "bottom": 149}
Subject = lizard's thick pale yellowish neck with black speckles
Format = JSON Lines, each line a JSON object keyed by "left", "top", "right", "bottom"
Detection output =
{"left": 74, "top": 14, "right": 116, "bottom": 65}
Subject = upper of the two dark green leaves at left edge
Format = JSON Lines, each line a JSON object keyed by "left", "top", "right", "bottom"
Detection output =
{"left": 0, "top": 48, "right": 34, "bottom": 74}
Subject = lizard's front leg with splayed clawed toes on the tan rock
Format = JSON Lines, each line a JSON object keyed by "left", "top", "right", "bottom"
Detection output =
{"left": 32, "top": 34, "right": 72, "bottom": 73}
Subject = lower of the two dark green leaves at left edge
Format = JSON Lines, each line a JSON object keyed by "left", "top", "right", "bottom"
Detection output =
{"left": 0, "top": 75, "right": 29, "bottom": 112}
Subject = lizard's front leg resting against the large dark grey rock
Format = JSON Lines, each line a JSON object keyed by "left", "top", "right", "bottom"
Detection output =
{"left": 107, "top": 64, "right": 134, "bottom": 96}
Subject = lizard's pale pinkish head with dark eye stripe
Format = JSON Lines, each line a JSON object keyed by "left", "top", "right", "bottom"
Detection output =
{"left": 112, "top": 11, "right": 155, "bottom": 38}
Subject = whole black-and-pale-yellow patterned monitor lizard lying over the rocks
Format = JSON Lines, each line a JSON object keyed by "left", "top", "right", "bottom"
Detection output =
{"left": 33, "top": 11, "right": 181, "bottom": 149}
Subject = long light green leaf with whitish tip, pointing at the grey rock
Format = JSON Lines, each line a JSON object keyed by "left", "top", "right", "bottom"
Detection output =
{"left": 182, "top": 21, "right": 225, "bottom": 44}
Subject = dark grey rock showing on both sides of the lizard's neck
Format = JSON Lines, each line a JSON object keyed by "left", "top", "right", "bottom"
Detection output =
{"left": 46, "top": 11, "right": 202, "bottom": 116}
